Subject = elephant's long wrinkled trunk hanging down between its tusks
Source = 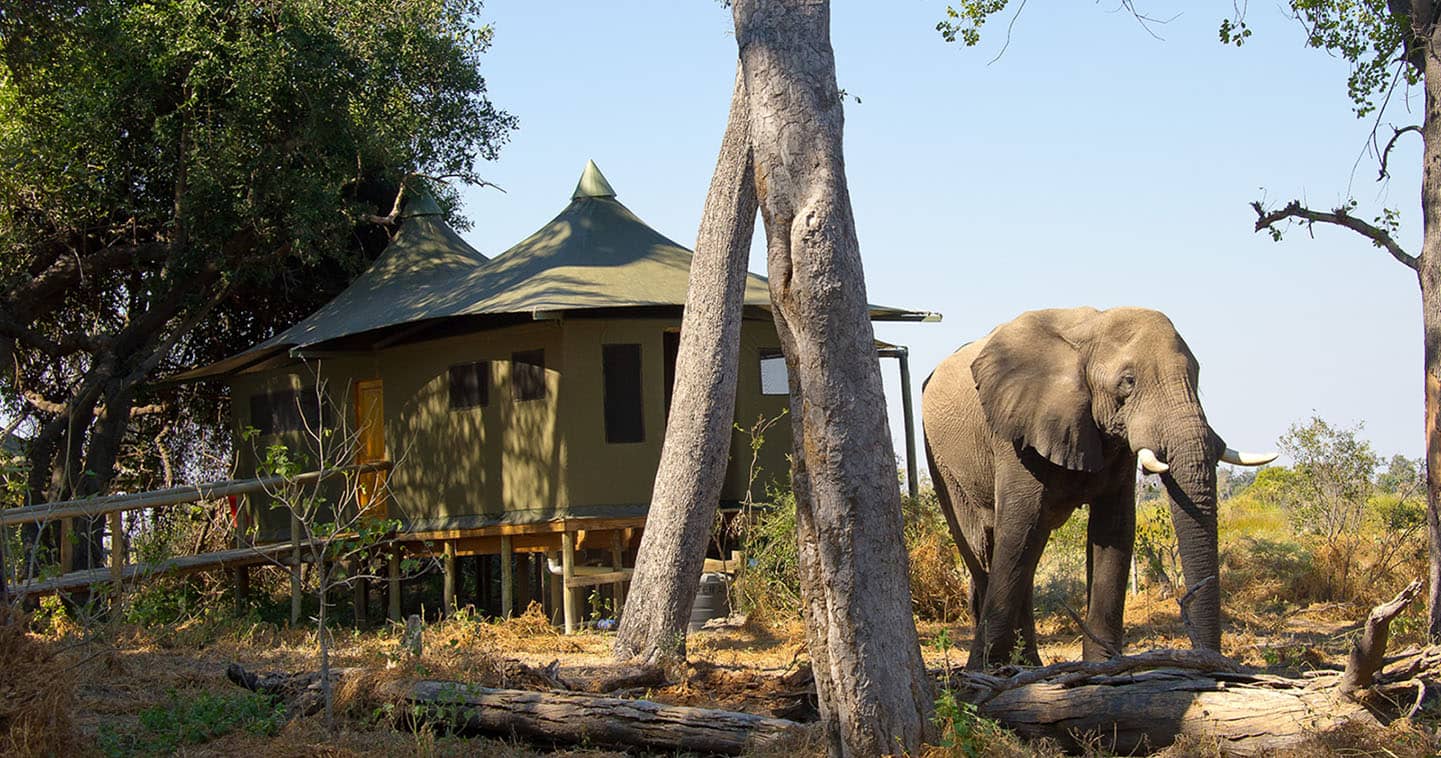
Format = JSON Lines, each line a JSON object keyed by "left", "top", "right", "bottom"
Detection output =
{"left": 1161, "top": 416, "right": 1221, "bottom": 650}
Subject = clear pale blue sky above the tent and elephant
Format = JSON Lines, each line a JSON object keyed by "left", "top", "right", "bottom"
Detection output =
{"left": 463, "top": 0, "right": 1424, "bottom": 468}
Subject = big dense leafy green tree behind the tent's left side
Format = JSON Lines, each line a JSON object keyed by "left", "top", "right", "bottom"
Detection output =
{"left": 0, "top": 0, "right": 516, "bottom": 565}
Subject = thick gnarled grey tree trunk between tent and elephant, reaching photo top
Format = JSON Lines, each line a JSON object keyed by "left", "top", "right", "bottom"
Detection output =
{"left": 733, "top": 0, "right": 932, "bottom": 755}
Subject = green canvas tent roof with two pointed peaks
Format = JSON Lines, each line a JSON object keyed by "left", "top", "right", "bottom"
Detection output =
{"left": 173, "top": 161, "right": 934, "bottom": 380}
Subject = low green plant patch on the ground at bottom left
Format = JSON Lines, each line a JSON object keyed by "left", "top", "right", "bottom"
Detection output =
{"left": 98, "top": 690, "right": 285, "bottom": 757}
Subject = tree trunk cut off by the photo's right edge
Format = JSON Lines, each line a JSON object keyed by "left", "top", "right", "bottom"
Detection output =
{"left": 1414, "top": 19, "right": 1441, "bottom": 641}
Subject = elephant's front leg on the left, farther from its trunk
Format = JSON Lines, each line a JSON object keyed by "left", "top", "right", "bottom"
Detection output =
{"left": 967, "top": 464, "right": 1050, "bottom": 669}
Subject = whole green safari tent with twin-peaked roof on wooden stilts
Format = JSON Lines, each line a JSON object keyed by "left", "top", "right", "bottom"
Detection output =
{"left": 179, "top": 163, "right": 931, "bottom": 634}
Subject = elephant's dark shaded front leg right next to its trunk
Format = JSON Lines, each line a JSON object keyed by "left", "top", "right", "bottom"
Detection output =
{"left": 1082, "top": 467, "right": 1136, "bottom": 660}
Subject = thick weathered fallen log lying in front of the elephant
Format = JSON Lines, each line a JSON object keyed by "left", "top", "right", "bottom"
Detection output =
{"left": 944, "top": 582, "right": 1441, "bottom": 755}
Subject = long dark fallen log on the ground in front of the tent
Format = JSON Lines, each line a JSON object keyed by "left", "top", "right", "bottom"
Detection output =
{"left": 226, "top": 664, "right": 808, "bottom": 755}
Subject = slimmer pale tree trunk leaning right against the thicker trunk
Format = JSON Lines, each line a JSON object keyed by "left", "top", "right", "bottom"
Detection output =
{"left": 615, "top": 72, "right": 757, "bottom": 663}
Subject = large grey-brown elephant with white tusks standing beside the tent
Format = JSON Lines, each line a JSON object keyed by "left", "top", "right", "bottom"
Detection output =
{"left": 921, "top": 307, "right": 1275, "bottom": 669}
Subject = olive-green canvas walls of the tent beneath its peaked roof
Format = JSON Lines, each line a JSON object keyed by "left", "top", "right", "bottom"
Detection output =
{"left": 231, "top": 318, "right": 790, "bottom": 540}
